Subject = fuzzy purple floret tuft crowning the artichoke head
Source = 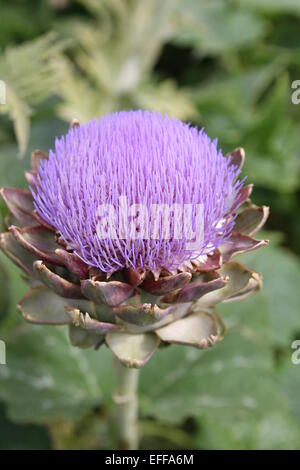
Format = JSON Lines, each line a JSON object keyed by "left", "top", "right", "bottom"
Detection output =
{"left": 32, "top": 110, "right": 242, "bottom": 273}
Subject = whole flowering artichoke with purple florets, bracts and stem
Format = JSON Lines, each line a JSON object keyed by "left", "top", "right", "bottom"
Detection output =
{"left": 0, "top": 111, "right": 268, "bottom": 448}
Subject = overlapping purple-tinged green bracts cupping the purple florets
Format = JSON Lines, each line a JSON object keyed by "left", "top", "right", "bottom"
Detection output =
{"left": 0, "top": 149, "right": 269, "bottom": 367}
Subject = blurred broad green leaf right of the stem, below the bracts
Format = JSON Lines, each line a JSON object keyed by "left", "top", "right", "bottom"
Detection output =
{"left": 141, "top": 332, "right": 286, "bottom": 423}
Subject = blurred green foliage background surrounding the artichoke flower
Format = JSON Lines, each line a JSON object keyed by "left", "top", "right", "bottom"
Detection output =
{"left": 0, "top": 0, "right": 300, "bottom": 449}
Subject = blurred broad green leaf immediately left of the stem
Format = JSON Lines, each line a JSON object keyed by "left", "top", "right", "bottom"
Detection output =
{"left": 0, "top": 324, "right": 112, "bottom": 423}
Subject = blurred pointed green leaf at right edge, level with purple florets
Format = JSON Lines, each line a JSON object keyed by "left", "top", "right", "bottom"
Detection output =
{"left": 244, "top": 75, "right": 300, "bottom": 191}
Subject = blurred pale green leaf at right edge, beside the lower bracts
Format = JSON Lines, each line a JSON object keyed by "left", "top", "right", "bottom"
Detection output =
{"left": 220, "top": 246, "right": 300, "bottom": 346}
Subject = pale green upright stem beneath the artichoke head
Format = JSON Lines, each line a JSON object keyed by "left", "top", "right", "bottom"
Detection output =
{"left": 113, "top": 358, "right": 139, "bottom": 450}
